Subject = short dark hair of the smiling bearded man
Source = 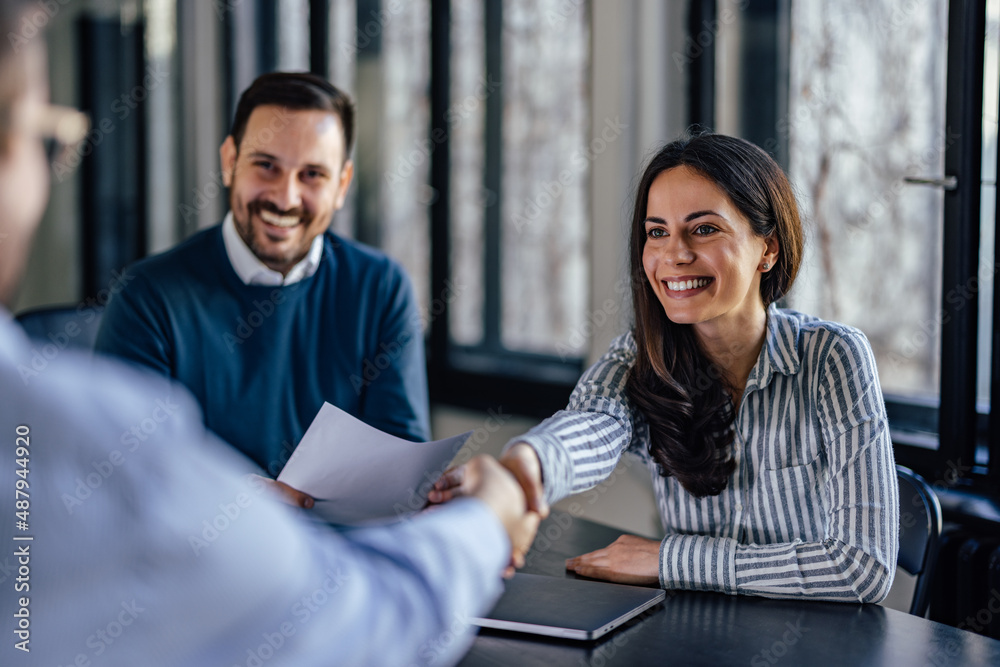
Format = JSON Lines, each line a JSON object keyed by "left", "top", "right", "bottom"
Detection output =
{"left": 229, "top": 72, "right": 354, "bottom": 161}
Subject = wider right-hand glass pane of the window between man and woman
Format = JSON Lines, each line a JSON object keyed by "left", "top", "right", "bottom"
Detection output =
{"left": 501, "top": 0, "right": 590, "bottom": 355}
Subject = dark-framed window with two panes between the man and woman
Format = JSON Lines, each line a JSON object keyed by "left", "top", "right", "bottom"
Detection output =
{"left": 430, "top": 0, "right": 589, "bottom": 416}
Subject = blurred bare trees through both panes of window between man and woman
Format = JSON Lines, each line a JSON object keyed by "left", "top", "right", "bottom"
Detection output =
{"left": 447, "top": 0, "right": 590, "bottom": 357}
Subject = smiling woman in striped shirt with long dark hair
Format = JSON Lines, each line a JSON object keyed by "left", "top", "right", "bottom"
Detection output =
{"left": 436, "top": 134, "right": 899, "bottom": 602}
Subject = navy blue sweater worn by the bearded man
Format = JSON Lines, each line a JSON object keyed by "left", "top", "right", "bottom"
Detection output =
{"left": 96, "top": 225, "right": 430, "bottom": 476}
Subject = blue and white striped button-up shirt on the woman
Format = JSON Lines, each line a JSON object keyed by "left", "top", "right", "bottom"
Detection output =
{"left": 508, "top": 305, "right": 899, "bottom": 602}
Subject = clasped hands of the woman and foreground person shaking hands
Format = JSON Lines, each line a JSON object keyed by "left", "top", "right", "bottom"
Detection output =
{"left": 428, "top": 443, "right": 549, "bottom": 577}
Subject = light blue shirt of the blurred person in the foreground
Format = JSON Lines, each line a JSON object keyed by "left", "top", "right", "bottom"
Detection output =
{"left": 0, "top": 308, "right": 510, "bottom": 667}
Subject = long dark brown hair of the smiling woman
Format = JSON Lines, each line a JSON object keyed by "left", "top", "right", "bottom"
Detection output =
{"left": 626, "top": 134, "right": 803, "bottom": 497}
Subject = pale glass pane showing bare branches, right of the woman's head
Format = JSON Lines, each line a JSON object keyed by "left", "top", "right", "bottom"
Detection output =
{"left": 778, "top": 0, "right": 948, "bottom": 397}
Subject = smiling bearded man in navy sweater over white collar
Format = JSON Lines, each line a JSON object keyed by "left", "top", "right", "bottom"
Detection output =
{"left": 97, "top": 72, "right": 429, "bottom": 505}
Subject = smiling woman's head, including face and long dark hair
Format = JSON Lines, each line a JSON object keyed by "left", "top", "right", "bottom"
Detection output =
{"left": 627, "top": 135, "right": 802, "bottom": 496}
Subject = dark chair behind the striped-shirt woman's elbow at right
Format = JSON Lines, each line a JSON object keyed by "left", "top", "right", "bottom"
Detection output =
{"left": 896, "top": 466, "right": 942, "bottom": 617}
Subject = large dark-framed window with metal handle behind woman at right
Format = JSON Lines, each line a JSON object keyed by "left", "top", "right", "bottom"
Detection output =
{"left": 712, "top": 0, "right": 1000, "bottom": 489}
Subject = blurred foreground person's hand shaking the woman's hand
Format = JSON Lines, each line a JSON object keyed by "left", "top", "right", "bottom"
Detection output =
{"left": 439, "top": 455, "right": 541, "bottom": 577}
